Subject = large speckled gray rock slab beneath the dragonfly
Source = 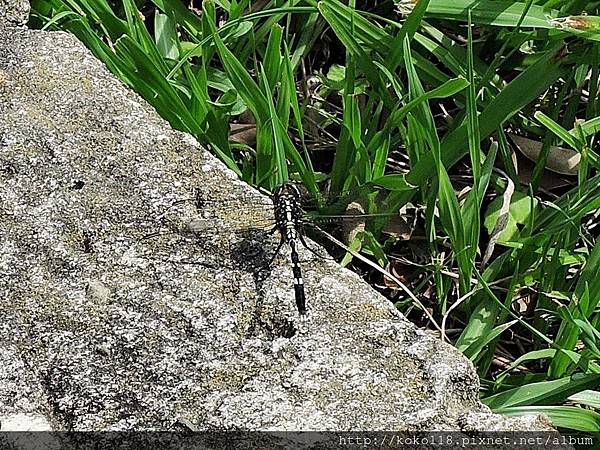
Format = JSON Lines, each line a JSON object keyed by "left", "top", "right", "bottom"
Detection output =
{"left": 0, "top": 21, "right": 549, "bottom": 440}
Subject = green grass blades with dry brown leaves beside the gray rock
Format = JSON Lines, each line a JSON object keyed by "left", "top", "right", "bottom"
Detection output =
{"left": 30, "top": 0, "right": 600, "bottom": 433}
